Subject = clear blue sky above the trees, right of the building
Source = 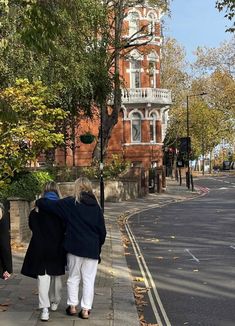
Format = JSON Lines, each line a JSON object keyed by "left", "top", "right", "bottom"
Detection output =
{"left": 164, "top": 0, "right": 231, "bottom": 62}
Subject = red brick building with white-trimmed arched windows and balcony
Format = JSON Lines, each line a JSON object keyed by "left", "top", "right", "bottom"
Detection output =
{"left": 56, "top": 6, "right": 171, "bottom": 170}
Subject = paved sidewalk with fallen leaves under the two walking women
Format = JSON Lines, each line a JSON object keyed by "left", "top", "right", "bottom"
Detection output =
{"left": 0, "top": 180, "right": 202, "bottom": 326}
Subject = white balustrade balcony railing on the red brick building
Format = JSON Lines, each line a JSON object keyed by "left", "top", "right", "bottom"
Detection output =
{"left": 122, "top": 88, "right": 172, "bottom": 105}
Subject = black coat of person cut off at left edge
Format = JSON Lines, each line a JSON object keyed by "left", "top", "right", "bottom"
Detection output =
{"left": 0, "top": 203, "right": 12, "bottom": 278}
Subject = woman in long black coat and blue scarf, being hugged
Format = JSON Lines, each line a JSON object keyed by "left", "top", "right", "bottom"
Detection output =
{"left": 21, "top": 181, "right": 66, "bottom": 321}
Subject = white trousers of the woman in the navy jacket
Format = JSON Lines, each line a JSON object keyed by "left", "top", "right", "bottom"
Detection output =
{"left": 67, "top": 254, "right": 98, "bottom": 309}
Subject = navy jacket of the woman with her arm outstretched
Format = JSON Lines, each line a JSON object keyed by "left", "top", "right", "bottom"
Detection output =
{"left": 36, "top": 192, "right": 106, "bottom": 259}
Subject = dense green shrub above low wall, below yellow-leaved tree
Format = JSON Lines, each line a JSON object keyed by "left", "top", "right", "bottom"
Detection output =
{"left": 2, "top": 171, "right": 52, "bottom": 201}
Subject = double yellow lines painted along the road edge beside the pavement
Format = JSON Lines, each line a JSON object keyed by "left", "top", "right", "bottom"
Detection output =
{"left": 125, "top": 214, "right": 171, "bottom": 326}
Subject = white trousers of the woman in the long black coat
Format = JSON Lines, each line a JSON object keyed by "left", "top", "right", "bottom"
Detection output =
{"left": 38, "top": 274, "right": 62, "bottom": 308}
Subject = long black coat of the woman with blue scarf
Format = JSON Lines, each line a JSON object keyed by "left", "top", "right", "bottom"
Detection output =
{"left": 21, "top": 202, "right": 66, "bottom": 278}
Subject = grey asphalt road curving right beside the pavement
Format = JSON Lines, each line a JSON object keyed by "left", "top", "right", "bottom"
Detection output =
{"left": 127, "top": 176, "right": 235, "bottom": 326}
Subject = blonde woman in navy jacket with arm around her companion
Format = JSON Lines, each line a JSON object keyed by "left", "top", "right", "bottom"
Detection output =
{"left": 36, "top": 177, "right": 106, "bottom": 319}
